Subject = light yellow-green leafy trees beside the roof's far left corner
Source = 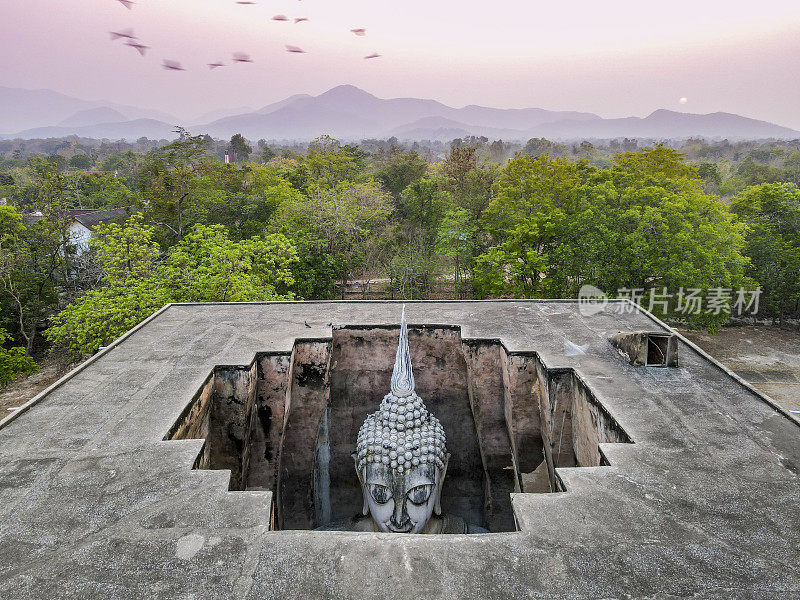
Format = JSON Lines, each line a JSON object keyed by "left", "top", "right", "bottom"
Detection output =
{"left": 46, "top": 217, "right": 297, "bottom": 354}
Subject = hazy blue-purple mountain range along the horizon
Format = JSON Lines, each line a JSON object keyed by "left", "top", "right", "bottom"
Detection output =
{"left": 0, "top": 85, "right": 800, "bottom": 141}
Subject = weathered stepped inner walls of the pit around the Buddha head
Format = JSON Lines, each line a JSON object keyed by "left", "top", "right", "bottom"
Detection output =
{"left": 169, "top": 326, "right": 630, "bottom": 531}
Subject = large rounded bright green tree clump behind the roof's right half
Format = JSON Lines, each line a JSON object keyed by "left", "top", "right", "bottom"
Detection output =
{"left": 476, "top": 147, "right": 747, "bottom": 327}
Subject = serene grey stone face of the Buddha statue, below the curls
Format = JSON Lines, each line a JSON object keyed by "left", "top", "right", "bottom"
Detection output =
{"left": 359, "top": 463, "right": 447, "bottom": 533}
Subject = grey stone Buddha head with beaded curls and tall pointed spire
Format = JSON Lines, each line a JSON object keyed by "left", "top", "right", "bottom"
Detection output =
{"left": 354, "top": 307, "right": 449, "bottom": 533}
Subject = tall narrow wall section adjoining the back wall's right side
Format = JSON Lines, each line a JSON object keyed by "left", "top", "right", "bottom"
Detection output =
{"left": 462, "top": 340, "right": 519, "bottom": 531}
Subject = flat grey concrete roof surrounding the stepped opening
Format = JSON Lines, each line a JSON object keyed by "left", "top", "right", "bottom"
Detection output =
{"left": 0, "top": 301, "right": 800, "bottom": 600}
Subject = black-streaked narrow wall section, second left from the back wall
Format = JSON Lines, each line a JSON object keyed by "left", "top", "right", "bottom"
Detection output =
{"left": 242, "top": 354, "right": 291, "bottom": 491}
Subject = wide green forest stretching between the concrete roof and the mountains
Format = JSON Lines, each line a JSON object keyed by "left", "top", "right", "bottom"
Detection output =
{"left": 0, "top": 130, "right": 800, "bottom": 384}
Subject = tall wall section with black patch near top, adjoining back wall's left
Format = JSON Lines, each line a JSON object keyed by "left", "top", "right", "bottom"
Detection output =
{"left": 276, "top": 341, "right": 331, "bottom": 529}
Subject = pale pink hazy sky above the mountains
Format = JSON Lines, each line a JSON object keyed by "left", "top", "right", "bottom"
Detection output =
{"left": 0, "top": 0, "right": 800, "bottom": 128}
